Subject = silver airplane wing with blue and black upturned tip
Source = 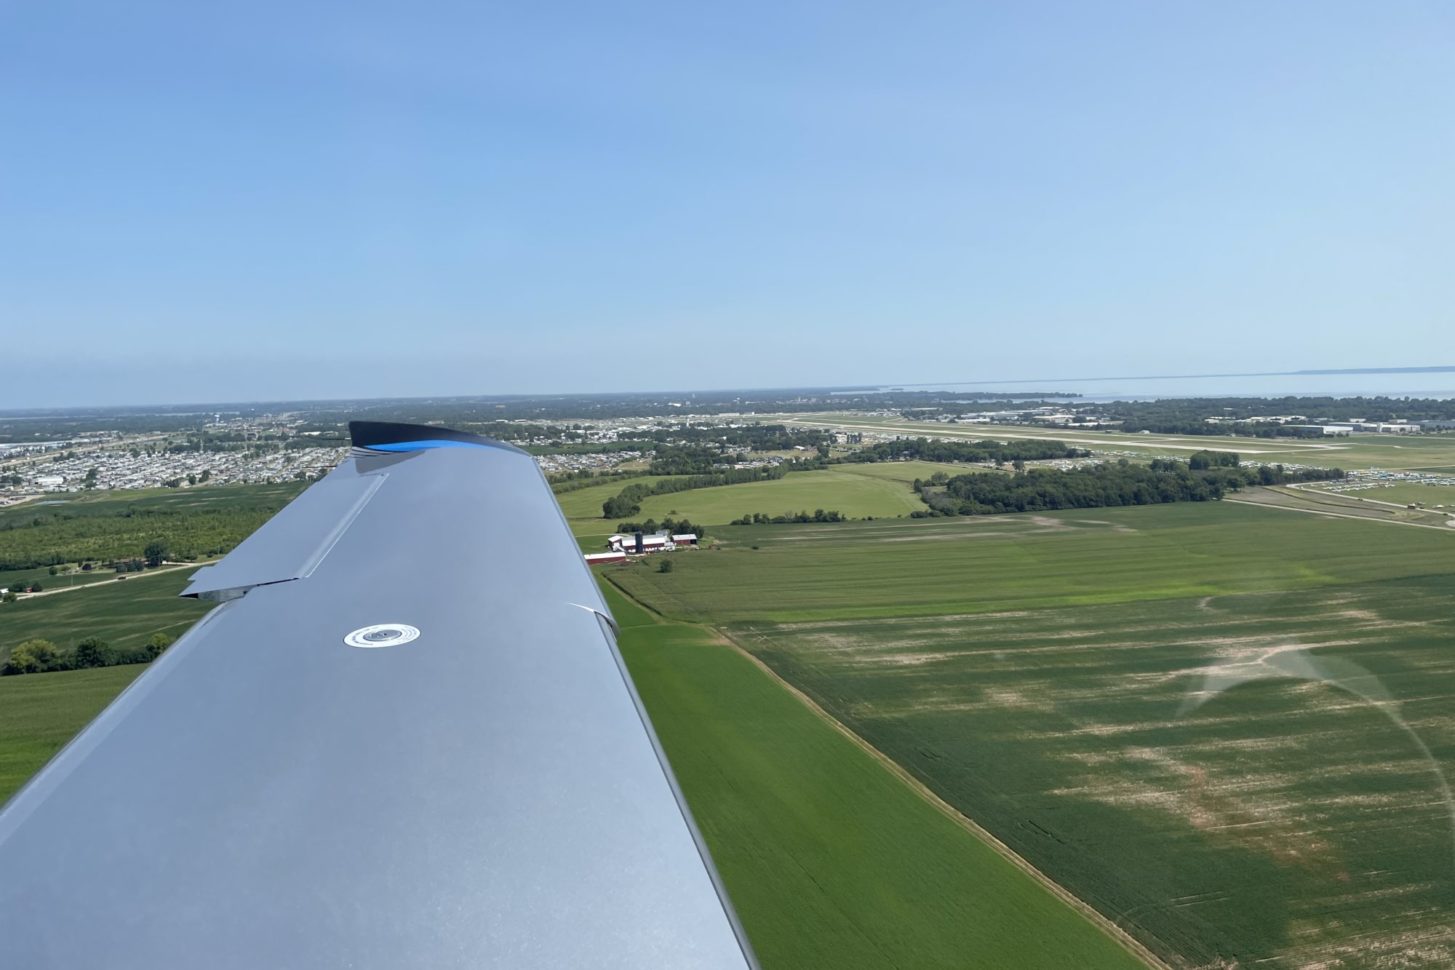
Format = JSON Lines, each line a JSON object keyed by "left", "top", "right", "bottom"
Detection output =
{"left": 0, "top": 422, "right": 754, "bottom": 970}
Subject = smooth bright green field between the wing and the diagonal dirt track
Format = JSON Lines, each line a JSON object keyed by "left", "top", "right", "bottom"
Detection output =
{"left": 607, "top": 588, "right": 1141, "bottom": 970}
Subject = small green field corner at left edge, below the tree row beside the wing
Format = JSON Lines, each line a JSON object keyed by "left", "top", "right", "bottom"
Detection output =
{"left": 0, "top": 663, "right": 147, "bottom": 804}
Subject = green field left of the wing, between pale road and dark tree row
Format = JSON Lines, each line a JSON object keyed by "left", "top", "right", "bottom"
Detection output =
{"left": 0, "top": 569, "right": 211, "bottom": 668}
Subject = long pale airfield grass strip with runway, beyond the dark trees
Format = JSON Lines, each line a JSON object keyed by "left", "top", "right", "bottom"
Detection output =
{"left": 791, "top": 413, "right": 1455, "bottom": 471}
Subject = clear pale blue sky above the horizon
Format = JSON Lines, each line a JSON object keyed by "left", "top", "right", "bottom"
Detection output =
{"left": 0, "top": 0, "right": 1455, "bottom": 407}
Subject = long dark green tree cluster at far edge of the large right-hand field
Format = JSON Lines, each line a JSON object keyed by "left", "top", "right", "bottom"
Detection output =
{"left": 912, "top": 452, "right": 1344, "bottom": 518}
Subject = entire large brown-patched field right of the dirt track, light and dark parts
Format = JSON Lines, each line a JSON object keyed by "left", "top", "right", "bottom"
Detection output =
{"left": 611, "top": 503, "right": 1455, "bottom": 967}
